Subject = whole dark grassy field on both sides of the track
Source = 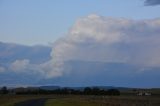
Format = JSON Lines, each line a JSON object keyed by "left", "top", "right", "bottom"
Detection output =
{"left": 0, "top": 95, "right": 160, "bottom": 106}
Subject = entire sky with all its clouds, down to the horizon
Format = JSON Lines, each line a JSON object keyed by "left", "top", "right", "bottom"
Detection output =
{"left": 0, "top": 0, "right": 160, "bottom": 88}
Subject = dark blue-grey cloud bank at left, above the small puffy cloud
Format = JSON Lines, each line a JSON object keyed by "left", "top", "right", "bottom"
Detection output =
{"left": 0, "top": 42, "right": 51, "bottom": 63}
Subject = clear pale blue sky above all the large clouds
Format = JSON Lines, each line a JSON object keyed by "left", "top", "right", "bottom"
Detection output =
{"left": 0, "top": 0, "right": 160, "bottom": 45}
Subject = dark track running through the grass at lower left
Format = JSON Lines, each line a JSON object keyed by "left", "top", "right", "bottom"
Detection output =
{"left": 14, "top": 98, "right": 47, "bottom": 106}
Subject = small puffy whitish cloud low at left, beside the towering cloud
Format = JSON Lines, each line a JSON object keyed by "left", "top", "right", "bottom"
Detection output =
{"left": 8, "top": 59, "right": 62, "bottom": 78}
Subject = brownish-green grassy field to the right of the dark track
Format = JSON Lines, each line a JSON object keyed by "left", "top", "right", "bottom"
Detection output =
{"left": 46, "top": 96, "right": 160, "bottom": 106}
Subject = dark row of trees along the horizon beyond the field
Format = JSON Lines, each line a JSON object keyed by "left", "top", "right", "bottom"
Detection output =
{"left": 0, "top": 87, "right": 120, "bottom": 95}
